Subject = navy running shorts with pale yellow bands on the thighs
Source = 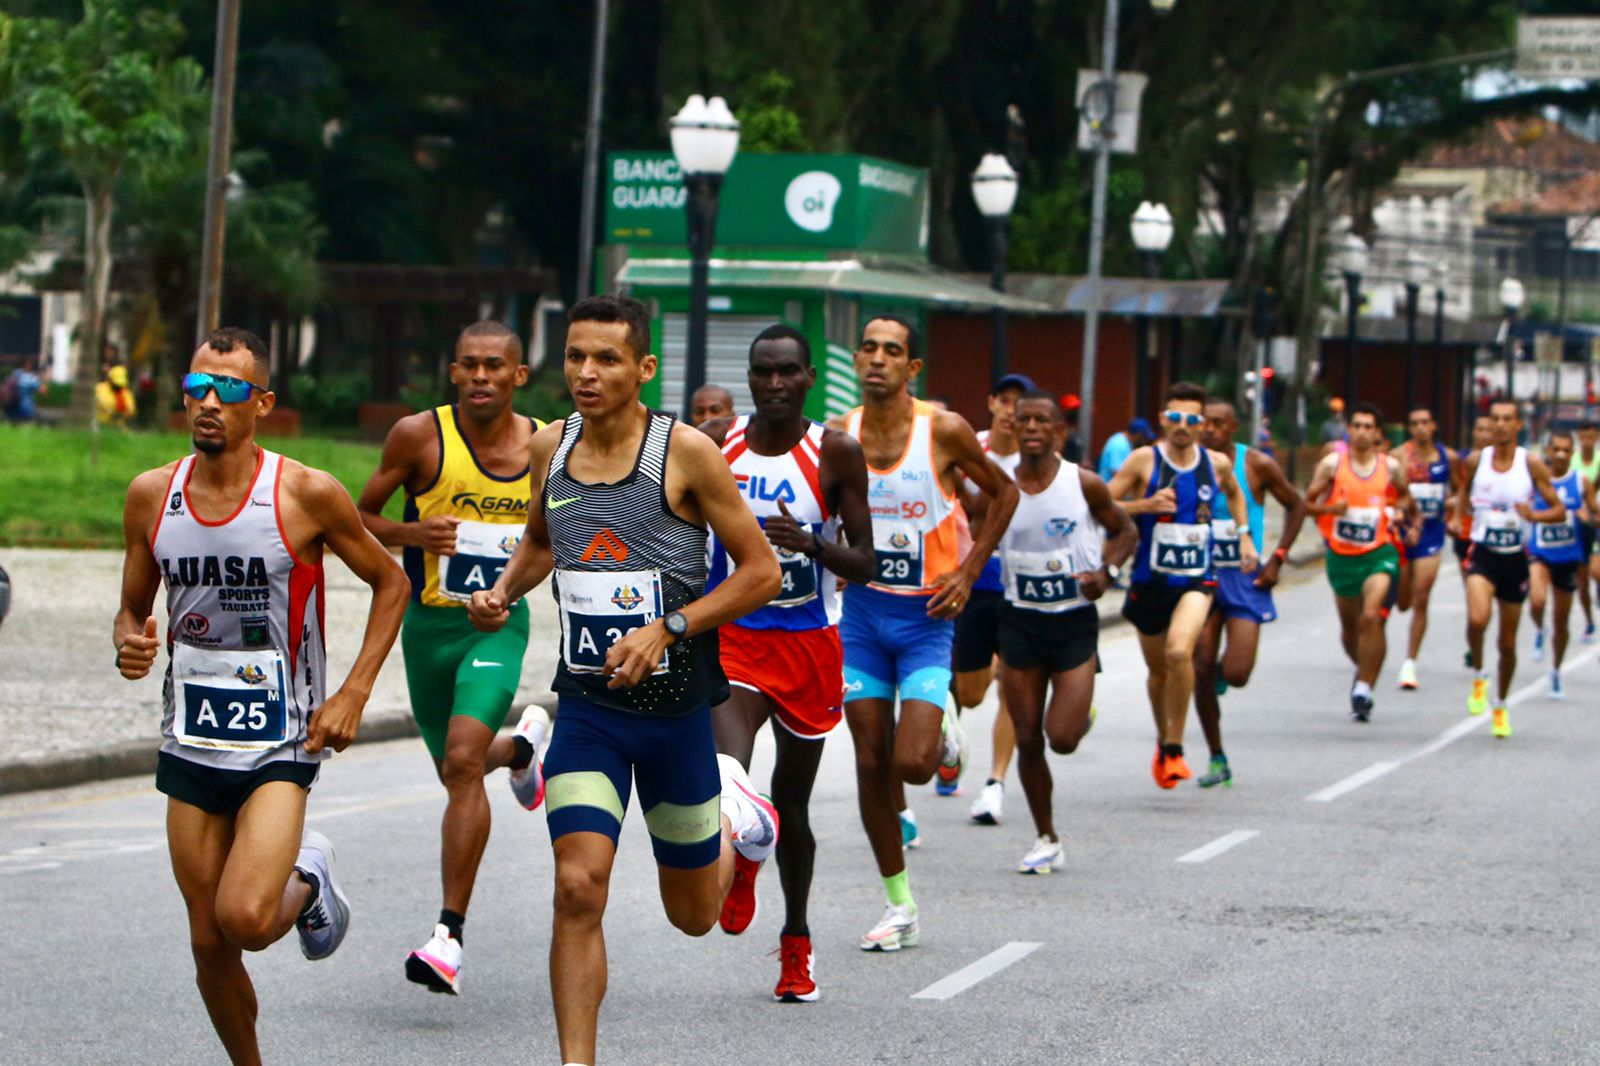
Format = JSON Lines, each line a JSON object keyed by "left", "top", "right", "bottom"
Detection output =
{"left": 544, "top": 696, "right": 722, "bottom": 869}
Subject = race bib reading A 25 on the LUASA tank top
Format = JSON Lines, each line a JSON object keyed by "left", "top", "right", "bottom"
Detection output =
{"left": 173, "top": 643, "right": 290, "bottom": 751}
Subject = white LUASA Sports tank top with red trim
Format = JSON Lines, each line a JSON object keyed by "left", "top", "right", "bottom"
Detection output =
{"left": 150, "top": 448, "right": 326, "bottom": 770}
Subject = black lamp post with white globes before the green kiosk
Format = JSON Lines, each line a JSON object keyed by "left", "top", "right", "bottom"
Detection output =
{"left": 670, "top": 93, "right": 739, "bottom": 416}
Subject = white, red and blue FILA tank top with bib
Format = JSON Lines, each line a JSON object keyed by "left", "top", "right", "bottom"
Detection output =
{"left": 706, "top": 415, "right": 838, "bottom": 631}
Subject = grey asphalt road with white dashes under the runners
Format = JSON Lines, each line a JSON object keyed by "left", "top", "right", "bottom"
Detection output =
{"left": 0, "top": 575, "right": 1600, "bottom": 1066}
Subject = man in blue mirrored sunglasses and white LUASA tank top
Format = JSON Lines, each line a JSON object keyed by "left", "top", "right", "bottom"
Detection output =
{"left": 112, "top": 328, "right": 405, "bottom": 1063}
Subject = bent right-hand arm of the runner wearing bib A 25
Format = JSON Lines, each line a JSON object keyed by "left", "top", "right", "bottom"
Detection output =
{"left": 296, "top": 463, "right": 411, "bottom": 754}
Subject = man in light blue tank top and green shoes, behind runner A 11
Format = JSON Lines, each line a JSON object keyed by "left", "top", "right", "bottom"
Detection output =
{"left": 1195, "top": 397, "right": 1306, "bottom": 789}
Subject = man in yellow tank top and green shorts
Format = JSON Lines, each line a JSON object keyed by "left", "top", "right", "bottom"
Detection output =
{"left": 360, "top": 322, "right": 549, "bottom": 996}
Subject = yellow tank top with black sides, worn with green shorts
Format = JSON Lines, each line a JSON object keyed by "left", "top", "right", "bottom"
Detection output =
{"left": 405, "top": 403, "right": 544, "bottom": 607}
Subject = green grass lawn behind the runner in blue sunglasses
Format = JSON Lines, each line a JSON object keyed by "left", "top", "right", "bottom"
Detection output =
{"left": 0, "top": 424, "right": 403, "bottom": 547}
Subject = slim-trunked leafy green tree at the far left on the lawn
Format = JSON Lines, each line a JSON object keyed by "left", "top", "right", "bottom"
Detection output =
{"left": 0, "top": 0, "right": 208, "bottom": 423}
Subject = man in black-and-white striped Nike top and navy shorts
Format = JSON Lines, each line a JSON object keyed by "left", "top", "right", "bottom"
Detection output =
{"left": 469, "top": 296, "right": 781, "bottom": 1064}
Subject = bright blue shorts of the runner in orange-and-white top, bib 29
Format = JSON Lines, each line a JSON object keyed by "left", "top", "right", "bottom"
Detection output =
{"left": 838, "top": 584, "right": 955, "bottom": 707}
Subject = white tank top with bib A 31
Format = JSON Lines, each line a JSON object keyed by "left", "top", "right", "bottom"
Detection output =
{"left": 1000, "top": 459, "right": 1101, "bottom": 615}
